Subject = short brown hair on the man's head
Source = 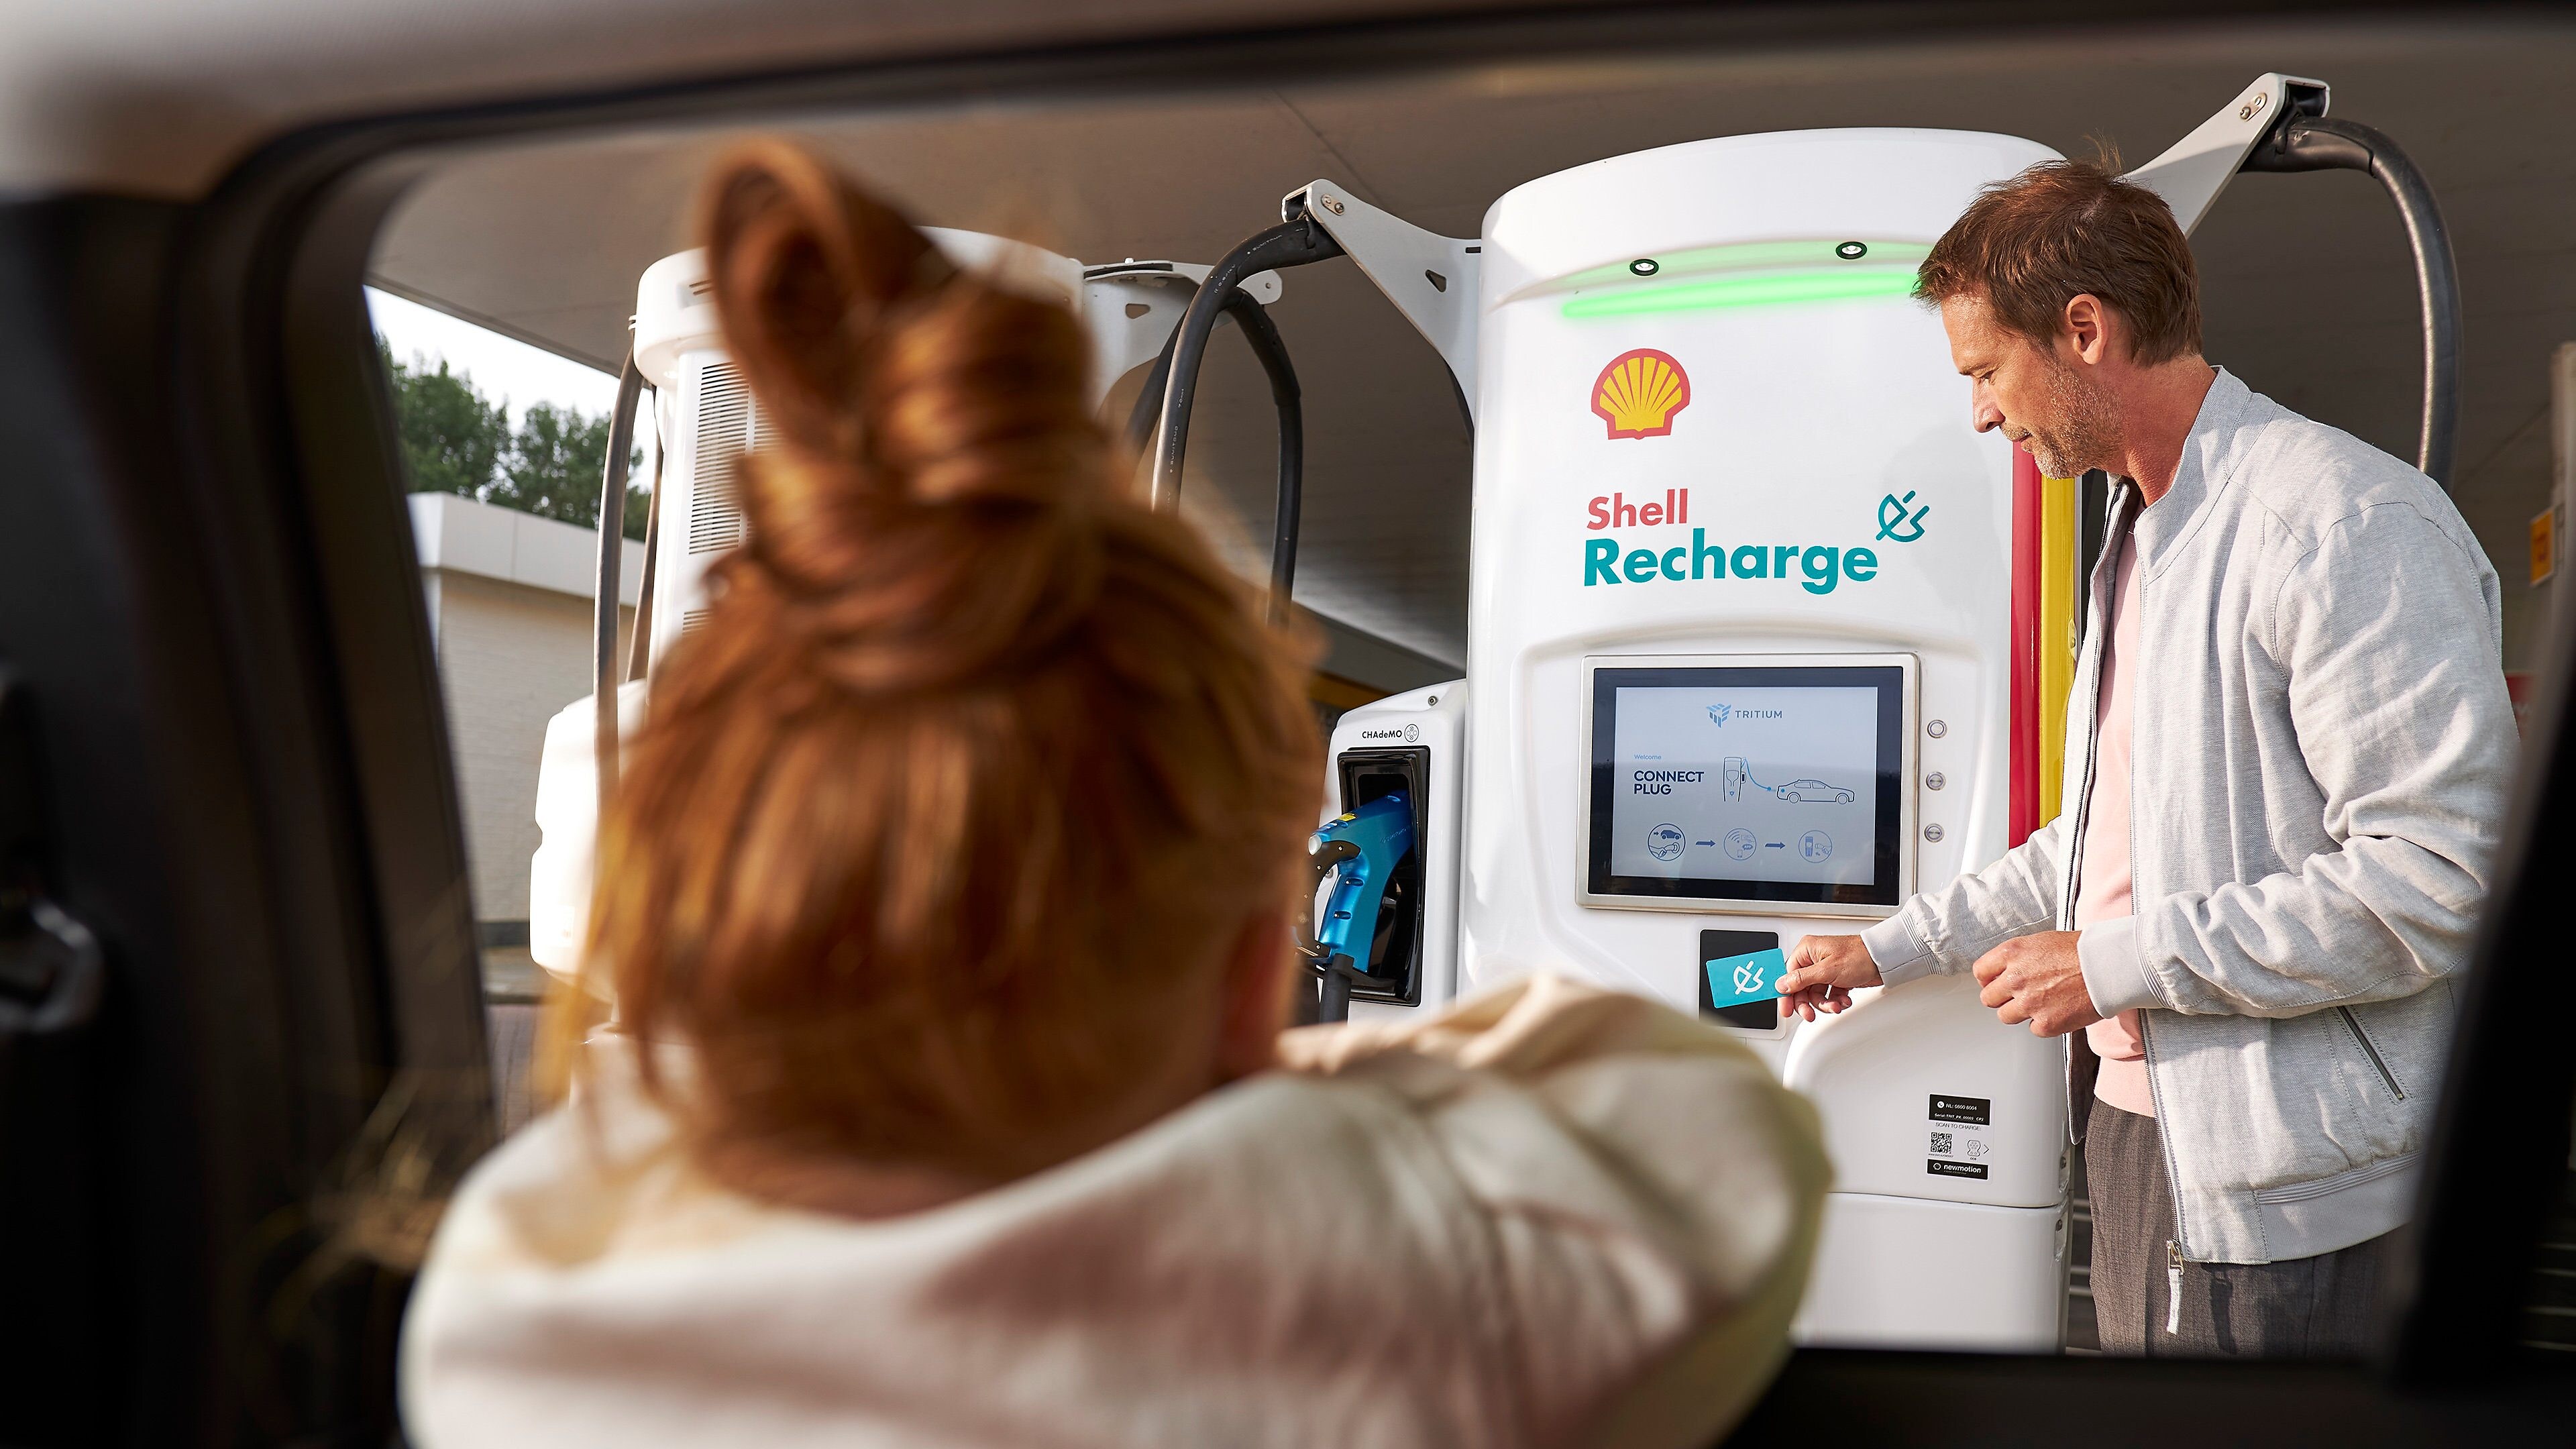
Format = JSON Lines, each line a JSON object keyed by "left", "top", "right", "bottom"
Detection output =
{"left": 1914, "top": 160, "right": 2200, "bottom": 364}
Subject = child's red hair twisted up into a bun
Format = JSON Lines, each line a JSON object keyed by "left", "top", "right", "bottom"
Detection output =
{"left": 572, "top": 142, "right": 1324, "bottom": 1178}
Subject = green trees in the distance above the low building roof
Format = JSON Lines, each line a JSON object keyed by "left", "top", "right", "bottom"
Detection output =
{"left": 376, "top": 337, "right": 652, "bottom": 539}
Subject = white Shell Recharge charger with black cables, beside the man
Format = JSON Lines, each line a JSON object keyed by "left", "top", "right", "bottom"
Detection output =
{"left": 1154, "top": 74, "right": 2457, "bottom": 1351}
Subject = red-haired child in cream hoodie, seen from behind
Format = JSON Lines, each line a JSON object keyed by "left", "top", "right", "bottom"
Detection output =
{"left": 402, "top": 144, "right": 1827, "bottom": 1449}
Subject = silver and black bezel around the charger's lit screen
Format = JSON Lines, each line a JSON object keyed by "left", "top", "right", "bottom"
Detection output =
{"left": 1582, "top": 655, "right": 1919, "bottom": 918}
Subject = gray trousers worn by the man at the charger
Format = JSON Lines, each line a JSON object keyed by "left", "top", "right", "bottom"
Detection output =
{"left": 2084, "top": 1101, "right": 2396, "bottom": 1358}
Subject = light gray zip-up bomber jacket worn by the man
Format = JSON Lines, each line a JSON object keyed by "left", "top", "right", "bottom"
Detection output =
{"left": 1862, "top": 371, "right": 2514, "bottom": 1263}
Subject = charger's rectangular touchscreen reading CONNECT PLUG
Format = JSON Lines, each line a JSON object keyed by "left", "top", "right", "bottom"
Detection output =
{"left": 1592, "top": 665, "right": 1904, "bottom": 905}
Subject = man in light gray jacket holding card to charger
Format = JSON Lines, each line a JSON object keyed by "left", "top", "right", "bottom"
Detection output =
{"left": 1780, "top": 162, "right": 2514, "bottom": 1356}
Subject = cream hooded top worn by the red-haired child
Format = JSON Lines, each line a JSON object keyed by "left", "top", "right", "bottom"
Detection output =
{"left": 402, "top": 977, "right": 1827, "bottom": 1449}
